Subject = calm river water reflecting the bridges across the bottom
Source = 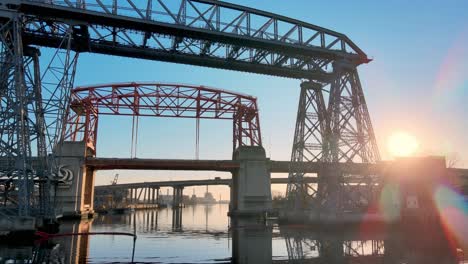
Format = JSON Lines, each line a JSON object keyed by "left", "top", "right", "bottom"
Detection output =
{"left": 0, "top": 204, "right": 468, "bottom": 264}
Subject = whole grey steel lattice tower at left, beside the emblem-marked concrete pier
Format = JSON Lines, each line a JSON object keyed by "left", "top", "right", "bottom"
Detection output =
{"left": 0, "top": 13, "right": 77, "bottom": 218}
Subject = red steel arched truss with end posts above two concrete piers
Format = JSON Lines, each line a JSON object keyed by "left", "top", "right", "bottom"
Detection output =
{"left": 64, "top": 82, "right": 262, "bottom": 154}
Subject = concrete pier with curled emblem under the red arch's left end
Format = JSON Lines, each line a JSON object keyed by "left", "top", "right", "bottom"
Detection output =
{"left": 55, "top": 142, "right": 95, "bottom": 218}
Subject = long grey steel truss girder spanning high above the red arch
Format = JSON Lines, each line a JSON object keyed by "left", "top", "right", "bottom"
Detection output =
{"left": 3, "top": 0, "right": 369, "bottom": 80}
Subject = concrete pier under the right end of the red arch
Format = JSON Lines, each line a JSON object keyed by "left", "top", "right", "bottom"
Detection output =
{"left": 229, "top": 146, "right": 271, "bottom": 216}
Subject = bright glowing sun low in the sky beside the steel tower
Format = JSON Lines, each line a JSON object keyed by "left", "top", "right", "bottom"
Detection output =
{"left": 388, "top": 131, "right": 419, "bottom": 157}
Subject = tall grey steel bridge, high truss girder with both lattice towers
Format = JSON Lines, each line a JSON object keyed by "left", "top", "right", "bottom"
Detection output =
{"left": 0, "top": 0, "right": 464, "bottom": 260}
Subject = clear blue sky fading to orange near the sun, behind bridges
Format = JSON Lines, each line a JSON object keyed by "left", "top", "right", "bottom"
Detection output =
{"left": 60, "top": 0, "right": 468, "bottom": 194}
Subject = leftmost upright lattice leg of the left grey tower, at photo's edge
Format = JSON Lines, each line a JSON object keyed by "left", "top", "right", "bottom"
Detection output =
{"left": 0, "top": 16, "right": 34, "bottom": 218}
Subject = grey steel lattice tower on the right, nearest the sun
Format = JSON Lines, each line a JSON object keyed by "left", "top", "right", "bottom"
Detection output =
{"left": 287, "top": 62, "right": 380, "bottom": 212}
